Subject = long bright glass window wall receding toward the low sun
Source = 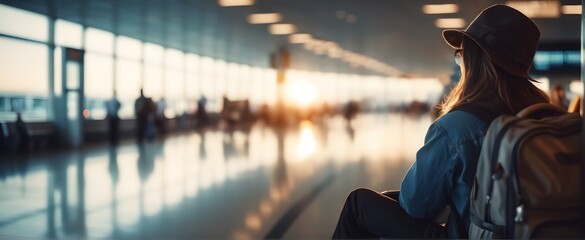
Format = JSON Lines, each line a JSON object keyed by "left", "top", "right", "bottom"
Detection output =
{"left": 0, "top": 4, "right": 444, "bottom": 124}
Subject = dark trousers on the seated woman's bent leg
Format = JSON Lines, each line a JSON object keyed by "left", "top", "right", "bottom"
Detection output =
{"left": 333, "top": 188, "right": 446, "bottom": 239}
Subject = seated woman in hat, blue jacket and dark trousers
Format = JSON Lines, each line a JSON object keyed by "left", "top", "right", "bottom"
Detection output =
{"left": 333, "top": 5, "right": 548, "bottom": 238}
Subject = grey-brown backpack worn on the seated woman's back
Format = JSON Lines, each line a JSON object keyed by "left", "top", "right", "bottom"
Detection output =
{"left": 469, "top": 103, "right": 584, "bottom": 239}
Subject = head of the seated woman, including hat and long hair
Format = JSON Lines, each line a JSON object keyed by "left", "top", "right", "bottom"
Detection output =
{"left": 441, "top": 5, "right": 548, "bottom": 114}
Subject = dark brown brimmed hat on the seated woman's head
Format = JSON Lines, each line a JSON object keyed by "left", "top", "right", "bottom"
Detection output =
{"left": 443, "top": 4, "right": 540, "bottom": 81}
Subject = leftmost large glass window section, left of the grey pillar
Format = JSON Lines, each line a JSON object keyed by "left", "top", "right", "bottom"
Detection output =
{"left": 0, "top": 4, "right": 49, "bottom": 122}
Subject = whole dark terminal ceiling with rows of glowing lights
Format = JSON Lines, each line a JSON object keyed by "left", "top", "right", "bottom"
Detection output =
{"left": 0, "top": 0, "right": 581, "bottom": 78}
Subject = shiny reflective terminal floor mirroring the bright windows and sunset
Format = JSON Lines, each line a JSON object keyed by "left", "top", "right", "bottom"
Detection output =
{"left": 0, "top": 114, "right": 431, "bottom": 239}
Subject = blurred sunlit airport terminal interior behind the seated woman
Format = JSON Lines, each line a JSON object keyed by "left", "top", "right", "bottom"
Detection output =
{"left": 0, "top": 0, "right": 584, "bottom": 239}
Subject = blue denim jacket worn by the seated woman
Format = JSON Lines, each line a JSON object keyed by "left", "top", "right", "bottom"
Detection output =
{"left": 400, "top": 111, "right": 488, "bottom": 231}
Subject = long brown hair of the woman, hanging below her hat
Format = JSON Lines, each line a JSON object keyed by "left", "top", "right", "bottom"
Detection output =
{"left": 440, "top": 37, "right": 549, "bottom": 115}
